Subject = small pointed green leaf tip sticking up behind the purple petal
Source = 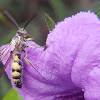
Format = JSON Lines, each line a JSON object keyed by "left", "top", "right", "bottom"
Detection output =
{"left": 44, "top": 13, "right": 55, "bottom": 31}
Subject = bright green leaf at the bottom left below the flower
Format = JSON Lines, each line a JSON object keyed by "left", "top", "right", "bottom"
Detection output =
{"left": 2, "top": 88, "right": 24, "bottom": 100}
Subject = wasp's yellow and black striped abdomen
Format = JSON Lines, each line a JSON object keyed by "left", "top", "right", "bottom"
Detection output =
{"left": 12, "top": 54, "right": 22, "bottom": 88}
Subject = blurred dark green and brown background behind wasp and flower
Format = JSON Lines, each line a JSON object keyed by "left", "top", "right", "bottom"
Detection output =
{"left": 0, "top": 0, "right": 100, "bottom": 100}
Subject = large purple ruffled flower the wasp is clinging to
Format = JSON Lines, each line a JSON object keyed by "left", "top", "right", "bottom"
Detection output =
{"left": 0, "top": 11, "right": 100, "bottom": 100}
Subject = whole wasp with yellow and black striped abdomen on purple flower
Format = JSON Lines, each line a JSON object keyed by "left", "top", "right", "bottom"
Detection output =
{"left": 0, "top": 11, "right": 43, "bottom": 88}
